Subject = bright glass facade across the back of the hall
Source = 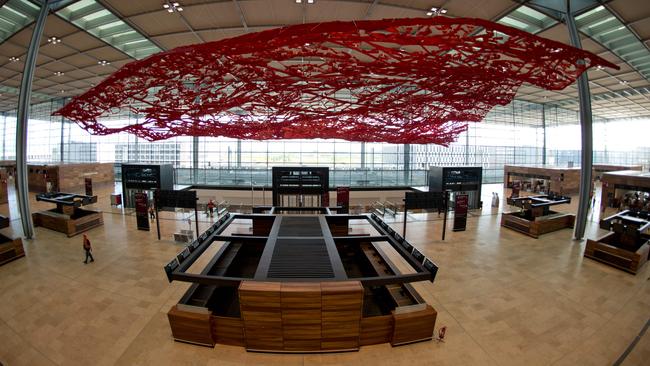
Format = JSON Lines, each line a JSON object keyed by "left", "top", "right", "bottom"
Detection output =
{"left": 0, "top": 100, "right": 650, "bottom": 187}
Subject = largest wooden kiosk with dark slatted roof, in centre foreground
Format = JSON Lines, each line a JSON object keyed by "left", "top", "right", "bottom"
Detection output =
{"left": 165, "top": 207, "right": 438, "bottom": 352}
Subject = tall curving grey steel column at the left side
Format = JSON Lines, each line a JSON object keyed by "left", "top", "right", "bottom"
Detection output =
{"left": 16, "top": 0, "right": 50, "bottom": 239}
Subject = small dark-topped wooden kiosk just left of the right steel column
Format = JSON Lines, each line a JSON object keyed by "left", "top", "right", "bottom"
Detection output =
{"left": 501, "top": 195, "right": 576, "bottom": 238}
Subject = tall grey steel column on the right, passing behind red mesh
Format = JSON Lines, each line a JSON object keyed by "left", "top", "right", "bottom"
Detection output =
{"left": 566, "top": 0, "right": 593, "bottom": 240}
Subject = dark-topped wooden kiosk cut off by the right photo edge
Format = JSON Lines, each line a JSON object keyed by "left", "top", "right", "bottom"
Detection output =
{"left": 585, "top": 210, "right": 650, "bottom": 274}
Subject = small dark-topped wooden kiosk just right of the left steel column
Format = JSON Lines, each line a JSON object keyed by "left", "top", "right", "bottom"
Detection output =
{"left": 32, "top": 193, "right": 104, "bottom": 237}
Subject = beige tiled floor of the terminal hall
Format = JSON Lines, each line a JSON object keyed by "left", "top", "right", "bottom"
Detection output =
{"left": 0, "top": 182, "right": 650, "bottom": 366}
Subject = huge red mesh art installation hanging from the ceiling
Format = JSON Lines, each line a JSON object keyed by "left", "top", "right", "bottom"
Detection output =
{"left": 55, "top": 17, "right": 616, "bottom": 145}
